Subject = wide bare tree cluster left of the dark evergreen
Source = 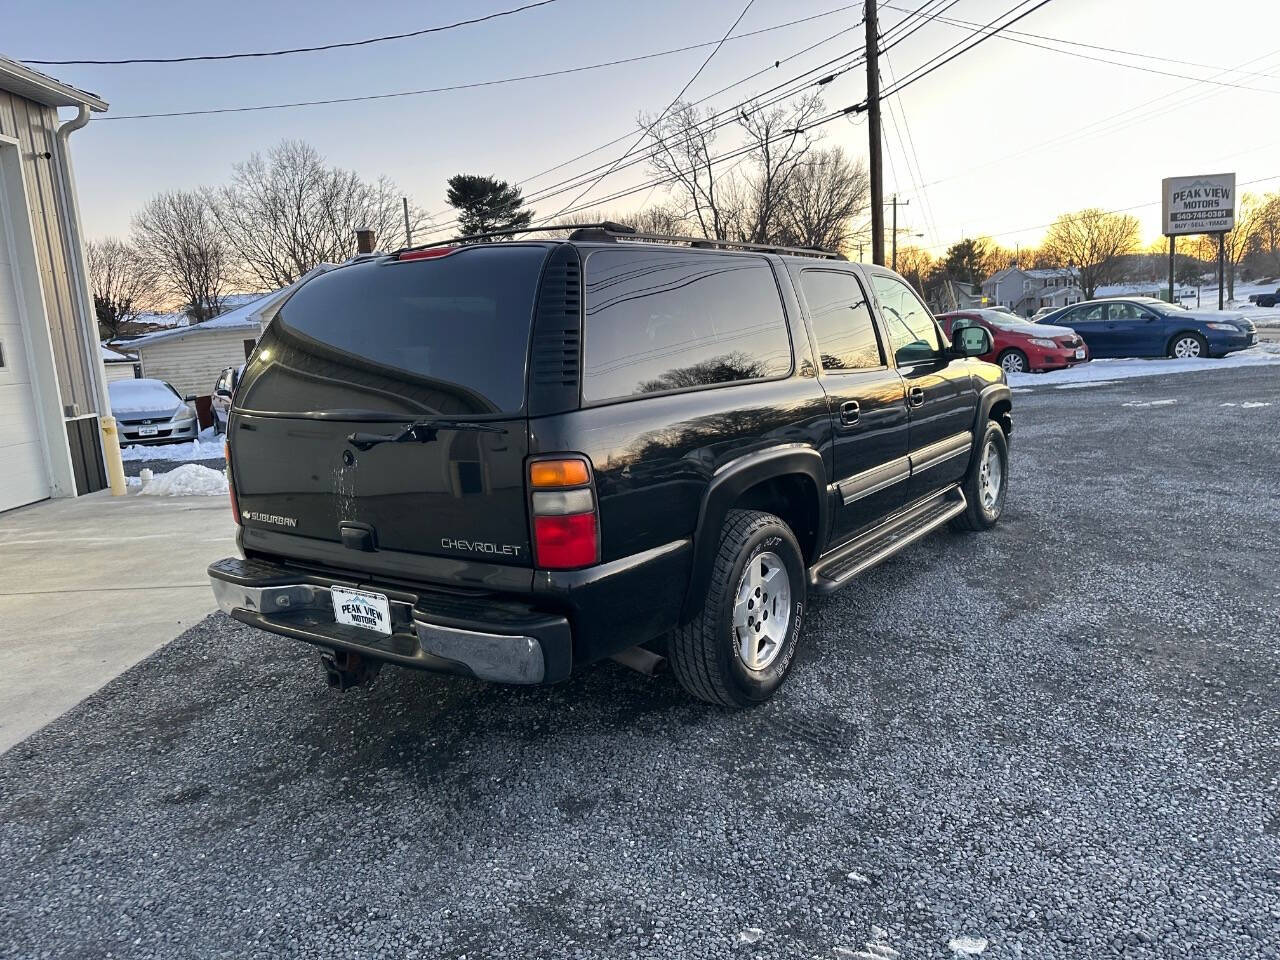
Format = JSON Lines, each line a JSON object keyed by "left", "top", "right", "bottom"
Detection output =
{"left": 205, "top": 140, "right": 428, "bottom": 288}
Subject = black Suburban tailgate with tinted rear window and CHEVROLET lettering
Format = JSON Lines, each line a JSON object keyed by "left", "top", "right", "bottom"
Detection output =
{"left": 229, "top": 243, "right": 547, "bottom": 581}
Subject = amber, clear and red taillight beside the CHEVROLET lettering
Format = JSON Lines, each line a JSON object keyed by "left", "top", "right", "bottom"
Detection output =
{"left": 529, "top": 454, "right": 600, "bottom": 570}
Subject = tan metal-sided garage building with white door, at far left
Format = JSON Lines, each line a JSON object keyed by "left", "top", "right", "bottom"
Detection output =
{"left": 0, "top": 56, "right": 108, "bottom": 511}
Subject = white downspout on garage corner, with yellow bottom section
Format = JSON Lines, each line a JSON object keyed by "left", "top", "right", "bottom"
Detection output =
{"left": 54, "top": 104, "right": 125, "bottom": 497}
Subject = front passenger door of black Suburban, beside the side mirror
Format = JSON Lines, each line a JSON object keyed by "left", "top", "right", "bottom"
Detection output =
{"left": 868, "top": 270, "right": 977, "bottom": 499}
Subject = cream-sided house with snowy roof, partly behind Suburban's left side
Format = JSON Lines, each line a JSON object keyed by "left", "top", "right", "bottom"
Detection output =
{"left": 126, "top": 264, "right": 333, "bottom": 397}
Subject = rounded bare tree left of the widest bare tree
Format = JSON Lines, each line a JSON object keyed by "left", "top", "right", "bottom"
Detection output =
{"left": 133, "top": 191, "right": 233, "bottom": 323}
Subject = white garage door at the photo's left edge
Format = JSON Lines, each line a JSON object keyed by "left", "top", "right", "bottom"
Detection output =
{"left": 0, "top": 161, "right": 49, "bottom": 509}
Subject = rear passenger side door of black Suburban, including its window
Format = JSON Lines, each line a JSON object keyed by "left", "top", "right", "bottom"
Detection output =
{"left": 792, "top": 268, "right": 910, "bottom": 543}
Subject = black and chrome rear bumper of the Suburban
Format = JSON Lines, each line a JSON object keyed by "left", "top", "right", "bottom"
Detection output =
{"left": 209, "top": 557, "right": 572, "bottom": 684}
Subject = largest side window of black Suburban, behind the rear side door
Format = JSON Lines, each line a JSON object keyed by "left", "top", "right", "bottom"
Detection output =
{"left": 582, "top": 248, "right": 791, "bottom": 403}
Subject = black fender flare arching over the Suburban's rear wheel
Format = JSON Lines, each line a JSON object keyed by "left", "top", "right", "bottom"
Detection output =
{"left": 680, "top": 443, "right": 829, "bottom": 623}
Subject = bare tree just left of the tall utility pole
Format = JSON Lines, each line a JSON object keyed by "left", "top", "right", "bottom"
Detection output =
{"left": 774, "top": 147, "right": 870, "bottom": 251}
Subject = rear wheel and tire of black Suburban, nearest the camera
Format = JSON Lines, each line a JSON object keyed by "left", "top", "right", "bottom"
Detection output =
{"left": 667, "top": 509, "right": 808, "bottom": 707}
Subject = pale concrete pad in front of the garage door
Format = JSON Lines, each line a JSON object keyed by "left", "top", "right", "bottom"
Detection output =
{"left": 0, "top": 492, "right": 236, "bottom": 751}
